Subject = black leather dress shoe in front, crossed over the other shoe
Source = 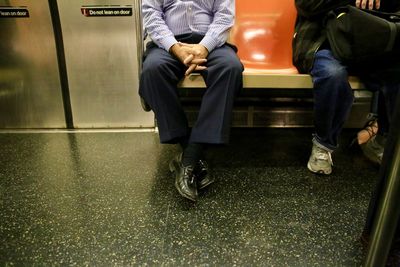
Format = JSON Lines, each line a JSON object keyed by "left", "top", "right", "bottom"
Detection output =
{"left": 169, "top": 154, "right": 198, "bottom": 201}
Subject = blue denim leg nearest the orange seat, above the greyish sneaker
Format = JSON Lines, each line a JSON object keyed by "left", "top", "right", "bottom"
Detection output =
{"left": 311, "top": 49, "right": 354, "bottom": 151}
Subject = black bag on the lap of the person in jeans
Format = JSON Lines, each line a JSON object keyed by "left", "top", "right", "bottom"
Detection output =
{"left": 326, "top": 6, "right": 400, "bottom": 66}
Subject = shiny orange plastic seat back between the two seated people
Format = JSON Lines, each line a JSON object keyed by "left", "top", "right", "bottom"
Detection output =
{"left": 230, "top": 0, "right": 298, "bottom": 74}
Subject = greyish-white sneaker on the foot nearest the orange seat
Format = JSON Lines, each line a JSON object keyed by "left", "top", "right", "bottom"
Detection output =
{"left": 307, "top": 144, "right": 333, "bottom": 175}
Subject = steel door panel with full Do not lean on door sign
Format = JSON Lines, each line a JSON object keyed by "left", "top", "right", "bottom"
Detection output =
{"left": 57, "top": 0, "right": 154, "bottom": 128}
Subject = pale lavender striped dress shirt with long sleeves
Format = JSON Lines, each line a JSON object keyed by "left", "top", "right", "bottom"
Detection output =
{"left": 142, "top": 0, "right": 235, "bottom": 52}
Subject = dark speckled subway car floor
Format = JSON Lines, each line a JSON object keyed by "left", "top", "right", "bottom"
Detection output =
{"left": 0, "top": 128, "right": 379, "bottom": 266}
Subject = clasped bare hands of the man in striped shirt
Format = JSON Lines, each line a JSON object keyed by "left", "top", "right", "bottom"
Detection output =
{"left": 170, "top": 43, "right": 208, "bottom": 75}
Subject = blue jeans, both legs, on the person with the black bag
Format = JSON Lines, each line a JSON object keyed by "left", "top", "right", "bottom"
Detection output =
{"left": 310, "top": 49, "right": 400, "bottom": 151}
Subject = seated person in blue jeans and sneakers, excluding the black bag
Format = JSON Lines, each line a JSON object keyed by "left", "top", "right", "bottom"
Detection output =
{"left": 293, "top": 0, "right": 400, "bottom": 175}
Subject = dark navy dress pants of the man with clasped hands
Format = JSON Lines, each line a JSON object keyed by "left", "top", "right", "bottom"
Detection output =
{"left": 139, "top": 37, "right": 243, "bottom": 144}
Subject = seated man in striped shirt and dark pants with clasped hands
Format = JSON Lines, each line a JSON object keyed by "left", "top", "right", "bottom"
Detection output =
{"left": 139, "top": 0, "right": 243, "bottom": 201}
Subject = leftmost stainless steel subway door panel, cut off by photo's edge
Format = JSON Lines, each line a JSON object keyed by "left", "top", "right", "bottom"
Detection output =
{"left": 0, "top": 0, "right": 66, "bottom": 128}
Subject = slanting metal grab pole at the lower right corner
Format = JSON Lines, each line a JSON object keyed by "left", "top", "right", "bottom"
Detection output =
{"left": 364, "top": 92, "right": 400, "bottom": 267}
